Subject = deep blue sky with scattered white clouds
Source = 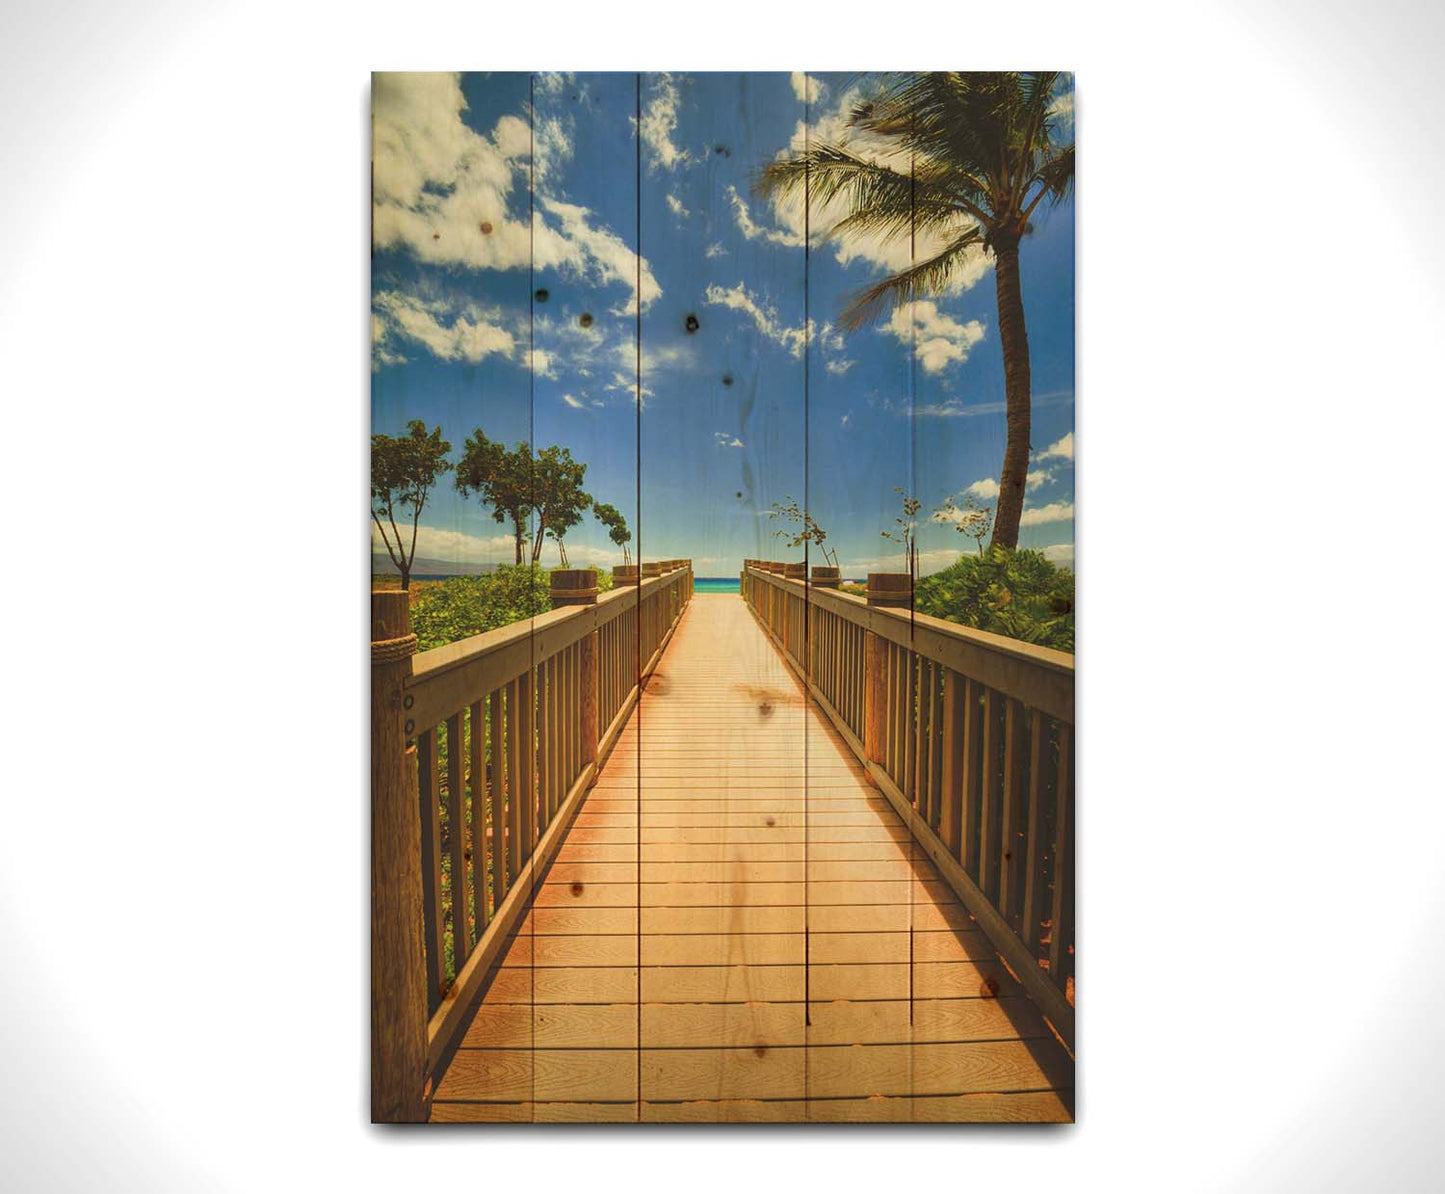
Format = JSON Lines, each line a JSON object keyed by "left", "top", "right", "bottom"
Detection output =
{"left": 371, "top": 72, "right": 1074, "bottom": 575}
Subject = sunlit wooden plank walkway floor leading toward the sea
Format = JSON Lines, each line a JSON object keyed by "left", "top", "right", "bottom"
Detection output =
{"left": 432, "top": 594, "right": 1074, "bottom": 1123}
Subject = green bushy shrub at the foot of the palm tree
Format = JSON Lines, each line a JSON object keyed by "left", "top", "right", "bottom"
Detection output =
{"left": 913, "top": 546, "right": 1074, "bottom": 652}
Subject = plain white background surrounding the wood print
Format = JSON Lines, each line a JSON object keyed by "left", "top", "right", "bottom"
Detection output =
{"left": 0, "top": 0, "right": 1445, "bottom": 1191}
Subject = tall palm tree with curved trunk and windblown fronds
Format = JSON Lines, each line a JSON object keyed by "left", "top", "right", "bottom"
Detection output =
{"left": 757, "top": 71, "right": 1074, "bottom": 548}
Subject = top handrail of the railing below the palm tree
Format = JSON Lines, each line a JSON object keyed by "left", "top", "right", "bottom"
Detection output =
{"left": 747, "top": 568, "right": 1074, "bottom": 723}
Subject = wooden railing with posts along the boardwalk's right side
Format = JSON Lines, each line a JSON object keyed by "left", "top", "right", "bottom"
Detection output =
{"left": 741, "top": 561, "right": 1074, "bottom": 1048}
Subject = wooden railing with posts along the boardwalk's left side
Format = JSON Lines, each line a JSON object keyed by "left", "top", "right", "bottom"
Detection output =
{"left": 371, "top": 559, "right": 692, "bottom": 1120}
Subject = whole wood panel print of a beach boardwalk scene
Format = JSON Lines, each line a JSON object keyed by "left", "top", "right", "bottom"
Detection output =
{"left": 371, "top": 71, "right": 1077, "bottom": 1123}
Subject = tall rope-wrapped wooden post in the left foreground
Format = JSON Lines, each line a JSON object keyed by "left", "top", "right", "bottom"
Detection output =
{"left": 371, "top": 590, "right": 428, "bottom": 1123}
